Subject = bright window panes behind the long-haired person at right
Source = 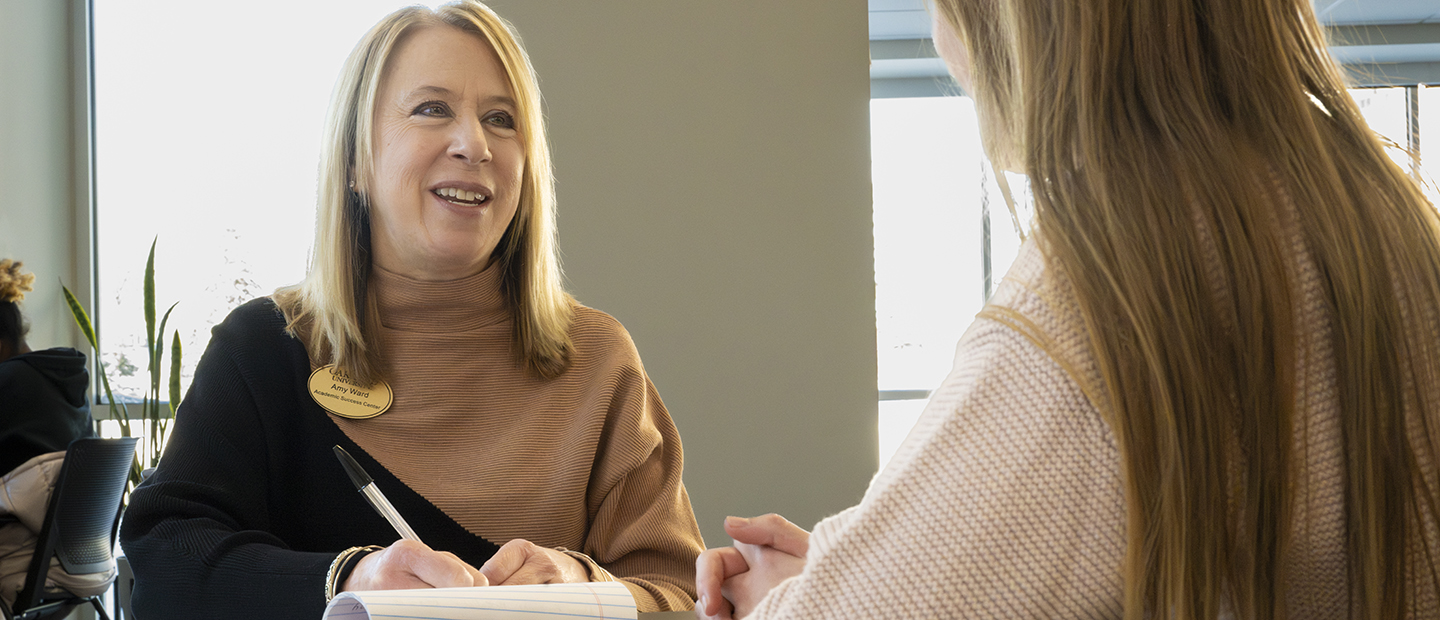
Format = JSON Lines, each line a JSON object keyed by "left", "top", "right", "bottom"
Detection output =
{"left": 870, "top": 86, "right": 1440, "bottom": 468}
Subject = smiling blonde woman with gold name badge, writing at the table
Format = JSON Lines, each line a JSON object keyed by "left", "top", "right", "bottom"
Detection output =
{"left": 121, "top": 1, "right": 704, "bottom": 620}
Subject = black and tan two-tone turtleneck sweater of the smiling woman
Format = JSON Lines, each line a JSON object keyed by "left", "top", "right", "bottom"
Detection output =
{"left": 121, "top": 260, "right": 704, "bottom": 620}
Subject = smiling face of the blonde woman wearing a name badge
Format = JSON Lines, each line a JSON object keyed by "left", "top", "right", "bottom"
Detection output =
{"left": 367, "top": 26, "right": 524, "bottom": 281}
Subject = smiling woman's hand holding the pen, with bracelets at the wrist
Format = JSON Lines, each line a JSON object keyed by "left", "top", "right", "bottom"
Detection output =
{"left": 340, "top": 539, "right": 488, "bottom": 591}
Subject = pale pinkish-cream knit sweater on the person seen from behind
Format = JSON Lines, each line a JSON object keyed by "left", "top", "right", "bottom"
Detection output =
{"left": 747, "top": 221, "right": 1440, "bottom": 620}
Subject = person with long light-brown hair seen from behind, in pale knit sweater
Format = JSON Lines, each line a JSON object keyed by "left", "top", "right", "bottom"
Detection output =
{"left": 697, "top": 0, "right": 1440, "bottom": 620}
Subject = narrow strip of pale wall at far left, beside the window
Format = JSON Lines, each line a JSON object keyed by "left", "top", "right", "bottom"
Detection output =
{"left": 0, "top": 0, "right": 85, "bottom": 348}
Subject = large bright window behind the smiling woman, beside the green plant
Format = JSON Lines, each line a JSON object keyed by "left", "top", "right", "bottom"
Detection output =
{"left": 94, "top": 0, "right": 410, "bottom": 400}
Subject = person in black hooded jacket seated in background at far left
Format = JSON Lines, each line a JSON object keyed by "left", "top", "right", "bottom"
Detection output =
{"left": 0, "top": 259, "right": 101, "bottom": 608}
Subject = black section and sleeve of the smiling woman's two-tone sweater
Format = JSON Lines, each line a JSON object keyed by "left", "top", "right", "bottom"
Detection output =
{"left": 120, "top": 299, "right": 498, "bottom": 620}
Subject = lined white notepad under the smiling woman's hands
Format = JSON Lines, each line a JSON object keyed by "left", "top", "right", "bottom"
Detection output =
{"left": 323, "top": 581, "right": 636, "bottom": 620}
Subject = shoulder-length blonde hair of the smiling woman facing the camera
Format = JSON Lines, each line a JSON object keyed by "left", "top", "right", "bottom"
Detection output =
{"left": 275, "top": 0, "right": 573, "bottom": 383}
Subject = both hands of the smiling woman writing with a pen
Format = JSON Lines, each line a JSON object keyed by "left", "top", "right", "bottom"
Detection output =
{"left": 341, "top": 538, "right": 589, "bottom": 591}
